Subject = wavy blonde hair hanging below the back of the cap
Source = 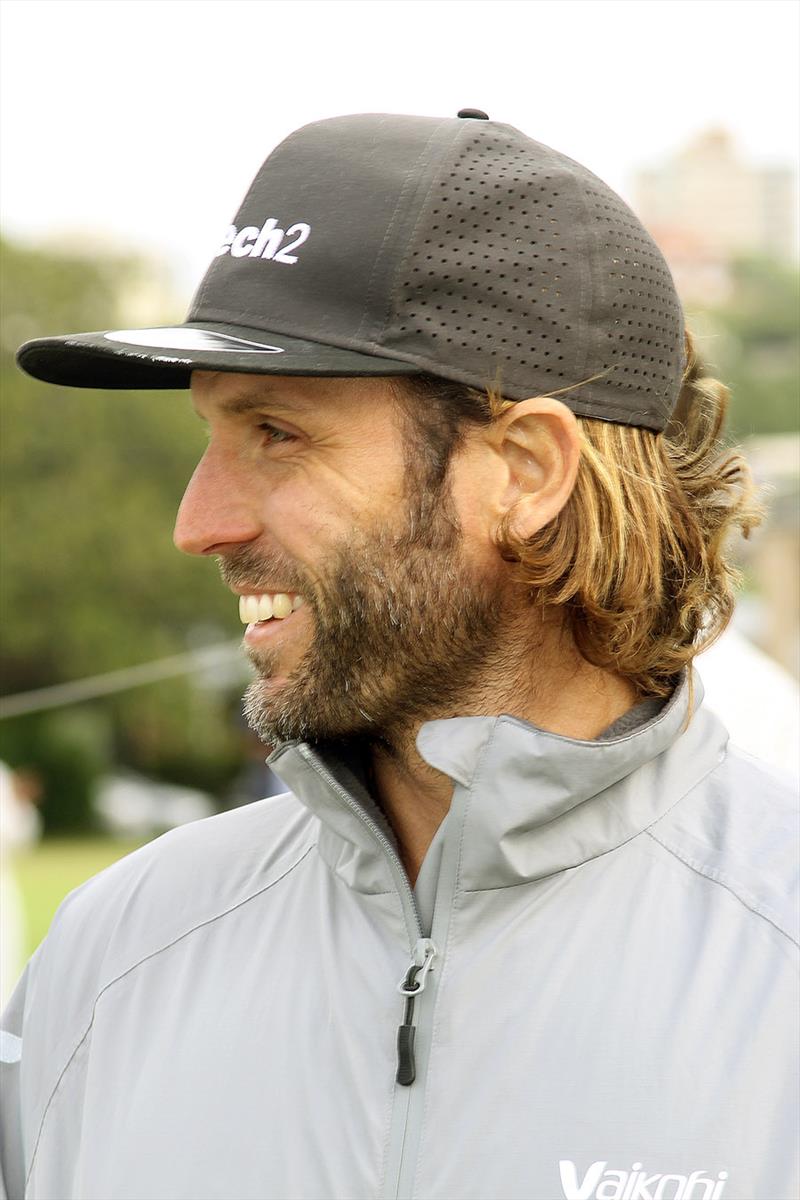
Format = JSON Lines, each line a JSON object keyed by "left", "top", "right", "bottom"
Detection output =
{"left": 400, "top": 331, "right": 763, "bottom": 696}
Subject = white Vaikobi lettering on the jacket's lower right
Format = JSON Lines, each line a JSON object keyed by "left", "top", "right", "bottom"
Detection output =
{"left": 559, "top": 1158, "right": 728, "bottom": 1200}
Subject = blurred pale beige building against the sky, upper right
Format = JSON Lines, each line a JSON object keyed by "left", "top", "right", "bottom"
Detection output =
{"left": 633, "top": 128, "right": 798, "bottom": 305}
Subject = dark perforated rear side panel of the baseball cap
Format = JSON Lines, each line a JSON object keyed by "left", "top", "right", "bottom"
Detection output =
{"left": 381, "top": 121, "right": 684, "bottom": 428}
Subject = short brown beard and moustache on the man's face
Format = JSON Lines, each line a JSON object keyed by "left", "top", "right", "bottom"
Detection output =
{"left": 221, "top": 472, "right": 513, "bottom": 746}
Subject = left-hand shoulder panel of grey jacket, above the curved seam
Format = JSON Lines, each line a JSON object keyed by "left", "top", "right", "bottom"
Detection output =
{"left": 15, "top": 793, "right": 318, "bottom": 1084}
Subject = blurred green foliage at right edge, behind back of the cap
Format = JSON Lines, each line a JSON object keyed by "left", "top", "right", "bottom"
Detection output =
{"left": 687, "top": 257, "right": 800, "bottom": 440}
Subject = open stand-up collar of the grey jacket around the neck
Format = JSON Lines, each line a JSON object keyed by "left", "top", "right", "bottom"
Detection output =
{"left": 269, "top": 674, "right": 728, "bottom": 893}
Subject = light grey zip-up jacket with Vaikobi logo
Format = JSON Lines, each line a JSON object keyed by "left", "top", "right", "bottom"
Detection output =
{"left": 2, "top": 682, "right": 800, "bottom": 1200}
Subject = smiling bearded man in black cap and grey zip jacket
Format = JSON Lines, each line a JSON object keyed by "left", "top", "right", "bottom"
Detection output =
{"left": 5, "top": 109, "right": 796, "bottom": 1200}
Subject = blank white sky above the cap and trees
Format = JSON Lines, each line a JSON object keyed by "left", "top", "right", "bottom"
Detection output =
{"left": 0, "top": 0, "right": 800, "bottom": 290}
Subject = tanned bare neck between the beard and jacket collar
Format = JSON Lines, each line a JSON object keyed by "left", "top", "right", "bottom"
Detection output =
{"left": 371, "top": 619, "right": 640, "bottom": 883}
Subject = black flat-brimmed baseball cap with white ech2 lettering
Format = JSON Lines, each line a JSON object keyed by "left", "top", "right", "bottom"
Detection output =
{"left": 18, "top": 109, "right": 685, "bottom": 430}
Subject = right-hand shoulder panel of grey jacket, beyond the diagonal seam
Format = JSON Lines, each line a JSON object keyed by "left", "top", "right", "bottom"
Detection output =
{"left": 648, "top": 743, "right": 800, "bottom": 944}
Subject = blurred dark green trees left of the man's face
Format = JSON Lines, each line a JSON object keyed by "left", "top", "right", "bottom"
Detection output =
{"left": 0, "top": 235, "right": 241, "bottom": 830}
